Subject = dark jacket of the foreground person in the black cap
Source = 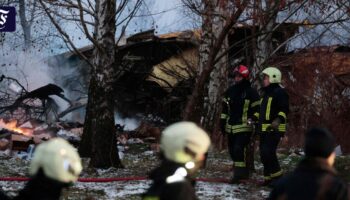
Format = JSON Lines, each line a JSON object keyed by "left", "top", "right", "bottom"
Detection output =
{"left": 268, "top": 158, "right": 349, "bottom": 200}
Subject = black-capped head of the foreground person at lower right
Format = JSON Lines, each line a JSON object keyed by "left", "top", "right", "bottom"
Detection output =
{"left": 304, "top": 127, "right": 336, "bottom": 166}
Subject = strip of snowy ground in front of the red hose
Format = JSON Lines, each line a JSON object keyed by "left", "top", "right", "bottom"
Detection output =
{"left": 0, "top": 181, "right": 268, "bottom": 200}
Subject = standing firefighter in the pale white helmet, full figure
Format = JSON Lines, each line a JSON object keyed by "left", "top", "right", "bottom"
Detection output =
{"left": 259, "top": 67, "right": 289, "bottom": 186}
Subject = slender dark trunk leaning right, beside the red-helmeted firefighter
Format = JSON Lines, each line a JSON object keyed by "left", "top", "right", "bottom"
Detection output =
{"left": 183, "top": 0, "right": 246, "bottom": 130}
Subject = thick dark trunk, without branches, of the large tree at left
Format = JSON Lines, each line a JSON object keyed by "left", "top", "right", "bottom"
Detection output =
{"left": 79, "top": 0, "right": 122, "bottom": 168}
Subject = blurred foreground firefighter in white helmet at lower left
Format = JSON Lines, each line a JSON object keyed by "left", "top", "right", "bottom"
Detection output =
{"left": 14, "top": 138, "right": 82, "bottom": 200}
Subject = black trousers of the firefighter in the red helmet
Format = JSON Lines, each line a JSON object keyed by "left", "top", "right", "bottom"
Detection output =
{"left": 228, "top": 132, "right": 252, "bottom": 168}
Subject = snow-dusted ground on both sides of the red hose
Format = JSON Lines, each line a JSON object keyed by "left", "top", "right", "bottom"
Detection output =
{"left": 0, "top": 140, "right": 350, "bottom": 200}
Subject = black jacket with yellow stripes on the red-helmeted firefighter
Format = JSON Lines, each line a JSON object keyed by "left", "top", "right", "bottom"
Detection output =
{"left": 221, "top": 80, "right": 260, "bottom": 133}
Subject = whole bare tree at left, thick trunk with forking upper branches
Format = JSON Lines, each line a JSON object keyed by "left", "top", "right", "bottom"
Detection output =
{"left": 40, "top": 0, "right": 143, "bottom": 168}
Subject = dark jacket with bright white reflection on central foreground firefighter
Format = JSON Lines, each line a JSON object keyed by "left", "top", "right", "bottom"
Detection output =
{"left": 142, "top": 161, "right": 197, "bottom": 200}
